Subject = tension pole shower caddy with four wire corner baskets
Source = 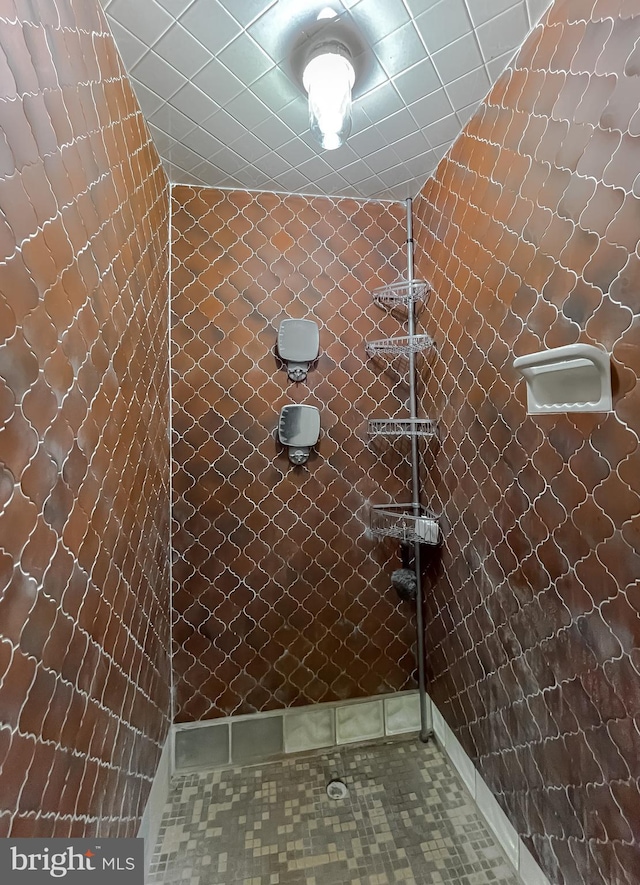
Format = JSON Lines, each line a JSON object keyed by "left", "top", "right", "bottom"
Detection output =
{"left": 366, "top": 199, "right": 439, "bottom": 741}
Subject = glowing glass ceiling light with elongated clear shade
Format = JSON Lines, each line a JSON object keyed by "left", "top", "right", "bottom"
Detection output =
{"left": 302, "top": 40, "right": 356, "bottom": 151}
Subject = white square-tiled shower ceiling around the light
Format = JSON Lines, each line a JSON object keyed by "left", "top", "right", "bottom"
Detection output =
{"left": 103, "top": 0, "right": 536, "bottom": 199}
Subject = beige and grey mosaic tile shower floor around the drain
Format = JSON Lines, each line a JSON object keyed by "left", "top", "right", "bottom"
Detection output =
{"left": 147, "top": 740, "right": 519, "bottom": 885}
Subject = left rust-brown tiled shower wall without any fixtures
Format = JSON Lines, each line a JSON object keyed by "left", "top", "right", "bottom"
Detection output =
{"left": 0, "top": 0, "right": 170, "bottom": 837}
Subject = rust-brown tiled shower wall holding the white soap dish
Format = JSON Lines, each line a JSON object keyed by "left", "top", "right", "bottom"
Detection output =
{"left": 416, "top": 0, "right": 640, "bottom": 885}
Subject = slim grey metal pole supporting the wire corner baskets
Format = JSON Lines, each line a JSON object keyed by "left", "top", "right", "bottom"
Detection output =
{"left": 406, "top": 198, "right": 431, "bottom": 743}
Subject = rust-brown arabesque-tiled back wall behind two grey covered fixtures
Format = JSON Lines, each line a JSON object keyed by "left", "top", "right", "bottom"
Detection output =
{"left": 172, "top": 187, "right": 415, "bottom": 722}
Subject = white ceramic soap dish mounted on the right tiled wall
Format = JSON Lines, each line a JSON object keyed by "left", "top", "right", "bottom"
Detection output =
{"left": 513, "top": 343, "right": 613, "bottom": 415}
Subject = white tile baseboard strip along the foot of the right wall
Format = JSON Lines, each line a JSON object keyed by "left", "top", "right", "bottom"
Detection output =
{"left": 429, "top": 698, "right": 550, "bottom": 885}
